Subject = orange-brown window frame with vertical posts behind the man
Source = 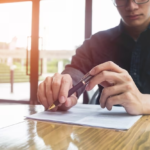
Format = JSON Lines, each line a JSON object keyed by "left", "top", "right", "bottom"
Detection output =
{"left": 0, "top": 0, "right": 92, "bottom": 104}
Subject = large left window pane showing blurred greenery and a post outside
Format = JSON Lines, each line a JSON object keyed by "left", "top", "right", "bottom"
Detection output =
{"left": 0, "top": 2, "right": 32, "bottom": 100}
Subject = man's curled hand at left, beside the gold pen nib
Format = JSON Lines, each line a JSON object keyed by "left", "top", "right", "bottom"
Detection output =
{"left": 37, "top": 73, "right": 77, "bottom": 111}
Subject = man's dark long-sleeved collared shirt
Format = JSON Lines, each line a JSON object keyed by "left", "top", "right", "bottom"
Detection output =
{"left": 63, "top": 22, "right": 150, "bottom": 103}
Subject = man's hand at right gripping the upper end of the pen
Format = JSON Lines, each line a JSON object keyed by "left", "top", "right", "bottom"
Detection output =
{"left": 86, "top": 62, "right": 145, "bottom": 115}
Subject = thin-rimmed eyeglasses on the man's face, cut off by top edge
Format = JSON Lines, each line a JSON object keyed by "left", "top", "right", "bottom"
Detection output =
{"left": 112, "top": 0, "right": 149, "bottom": 7}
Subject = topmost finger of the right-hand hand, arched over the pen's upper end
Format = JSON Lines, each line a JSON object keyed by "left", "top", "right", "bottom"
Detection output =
{"left": 90, "top": 61, "right": 125, "bottom": 75}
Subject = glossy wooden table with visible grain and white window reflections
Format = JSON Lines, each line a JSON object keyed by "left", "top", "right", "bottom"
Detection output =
{"left": 0, "top": 104, "right": 150, "bottom": 150}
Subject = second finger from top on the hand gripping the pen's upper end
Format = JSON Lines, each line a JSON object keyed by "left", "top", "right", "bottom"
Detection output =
{"left": 87, "top": 71, "right": 124, "bottom": 90}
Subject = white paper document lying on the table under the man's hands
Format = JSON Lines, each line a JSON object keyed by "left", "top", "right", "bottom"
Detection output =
{"left": 26, "top": 104, "right": 141, "bottom": 130}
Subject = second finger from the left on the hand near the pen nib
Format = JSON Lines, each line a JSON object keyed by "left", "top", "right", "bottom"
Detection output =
{"left": 44, "top": 77, "right": 54, "bottom": 106}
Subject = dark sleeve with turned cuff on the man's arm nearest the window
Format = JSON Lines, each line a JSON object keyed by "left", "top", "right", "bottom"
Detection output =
{"left": 62, "top": 31, "right": 109, "bottom": 98}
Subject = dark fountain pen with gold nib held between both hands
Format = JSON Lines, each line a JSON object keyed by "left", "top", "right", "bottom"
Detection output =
{"left": 49, "top": 73, "right": 93, "bottom": 110}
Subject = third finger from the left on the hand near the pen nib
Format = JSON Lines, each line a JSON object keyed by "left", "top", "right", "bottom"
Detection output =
{"left": 51, "top": 73, "right": 62, "bottom": 101}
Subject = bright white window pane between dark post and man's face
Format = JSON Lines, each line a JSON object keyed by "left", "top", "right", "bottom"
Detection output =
{"left": 92, "top": 0, "right": 120, "bottom": 34}
